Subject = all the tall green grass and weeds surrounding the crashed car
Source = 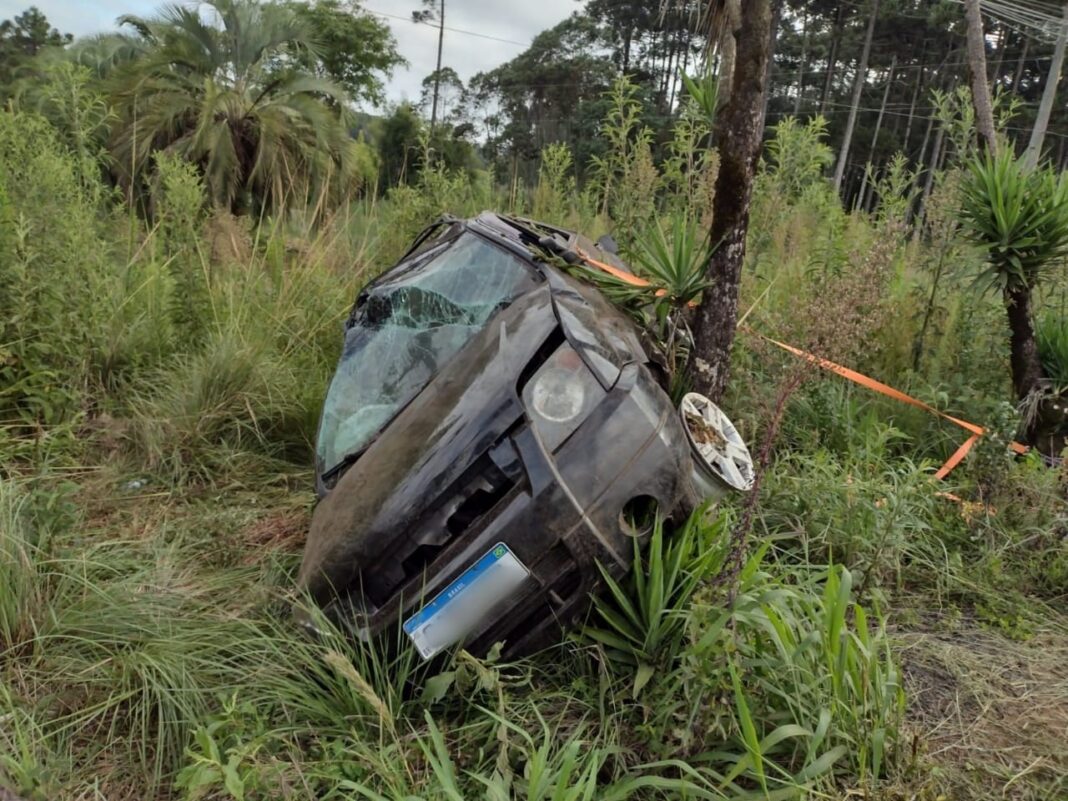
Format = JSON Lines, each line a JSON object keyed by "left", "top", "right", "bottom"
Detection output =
{"left": 0, "top": 103, "right": 1068, "bottom": 801}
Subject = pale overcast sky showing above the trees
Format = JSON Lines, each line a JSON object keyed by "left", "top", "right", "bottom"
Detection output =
{"left": 0, "top": 0, "right": 580, "bottom": 108}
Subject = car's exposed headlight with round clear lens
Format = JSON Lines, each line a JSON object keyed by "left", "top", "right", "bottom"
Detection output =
{"left": 523, "top": 345, "right": 604, "bottom": 451}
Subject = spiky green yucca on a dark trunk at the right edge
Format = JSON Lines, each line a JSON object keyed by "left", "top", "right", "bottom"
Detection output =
{"left": 960, "top": 148, "right": 1068, "bottom": 407}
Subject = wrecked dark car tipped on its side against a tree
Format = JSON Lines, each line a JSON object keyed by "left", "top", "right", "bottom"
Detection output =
{"left": 298, "top": 214, "right": 753, "bottom": 658}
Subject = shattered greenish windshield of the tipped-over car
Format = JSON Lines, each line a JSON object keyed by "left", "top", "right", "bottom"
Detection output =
{"left": 318, "top": 233, "right": 535, "bottom": 473}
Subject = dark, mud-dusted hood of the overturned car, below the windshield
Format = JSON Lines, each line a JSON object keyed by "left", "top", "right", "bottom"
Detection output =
{"left": 298, "top": 285, "right": 557, "bottom": 603}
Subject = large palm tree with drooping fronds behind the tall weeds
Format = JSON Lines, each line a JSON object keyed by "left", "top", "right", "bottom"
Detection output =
{"left": 111, "top": 0, "right": 355, "bottom": 214}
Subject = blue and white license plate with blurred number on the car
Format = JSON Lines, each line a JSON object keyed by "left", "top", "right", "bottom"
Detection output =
{"left": 404, "top": 543, "right": 530, "bottom": 659}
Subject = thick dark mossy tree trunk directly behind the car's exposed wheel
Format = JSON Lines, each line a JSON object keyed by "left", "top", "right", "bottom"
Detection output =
{"left": 690, "top": 0, "right": 771, "bottom": 401}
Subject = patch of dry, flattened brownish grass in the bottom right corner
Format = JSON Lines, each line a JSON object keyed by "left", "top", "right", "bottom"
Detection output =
{"left": 898, "top": 626, "right": 1068, "bottom": 801}
